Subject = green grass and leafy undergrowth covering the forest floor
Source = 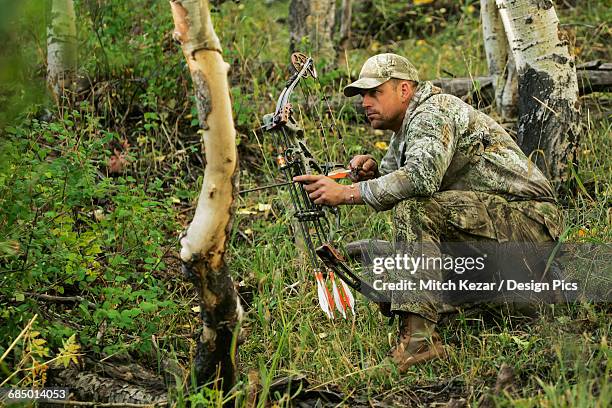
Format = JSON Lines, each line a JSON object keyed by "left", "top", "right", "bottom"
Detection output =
{"left": 0, "top": 0, "right": 612, "bottom": 407}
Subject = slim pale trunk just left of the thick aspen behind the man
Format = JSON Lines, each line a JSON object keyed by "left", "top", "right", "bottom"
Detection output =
{"left": 480, "top": 0, "right": 518, "bottom": 122}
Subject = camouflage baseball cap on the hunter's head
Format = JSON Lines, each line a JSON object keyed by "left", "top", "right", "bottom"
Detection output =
{"left": 344, "top": 54, "right": 419, "bottom": 96}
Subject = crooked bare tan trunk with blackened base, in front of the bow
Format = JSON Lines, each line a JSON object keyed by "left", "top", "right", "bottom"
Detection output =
{"left": 170, "top": 0, "right": 242, "bottom": 390}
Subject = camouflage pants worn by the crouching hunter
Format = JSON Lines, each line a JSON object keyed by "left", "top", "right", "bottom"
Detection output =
{"left": 390, "top": 190, "right": 561, "bottom": 322}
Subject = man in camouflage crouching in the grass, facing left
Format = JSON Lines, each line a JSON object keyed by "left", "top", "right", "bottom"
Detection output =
{"left": 295, "top": 54, "right": 560, "bottom": 371}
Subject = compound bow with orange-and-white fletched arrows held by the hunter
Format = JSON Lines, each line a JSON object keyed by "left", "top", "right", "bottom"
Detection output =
{"left": 261, "top": 53, "right": 385, "bottom": 318}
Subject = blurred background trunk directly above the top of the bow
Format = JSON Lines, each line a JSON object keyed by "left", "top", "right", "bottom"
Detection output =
{"left": 289, "top": 0, "right": 336, "bottom": 60}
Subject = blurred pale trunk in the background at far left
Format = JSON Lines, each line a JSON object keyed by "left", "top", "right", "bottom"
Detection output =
{"left": 47, "top": 0, "right": 77, "bottom": 101}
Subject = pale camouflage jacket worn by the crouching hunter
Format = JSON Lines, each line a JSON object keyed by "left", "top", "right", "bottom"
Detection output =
{"left": 359, "top": 82, "right": 555, "bottom": 211}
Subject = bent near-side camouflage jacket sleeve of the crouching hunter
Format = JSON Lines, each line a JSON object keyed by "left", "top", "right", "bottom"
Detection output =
{"left": 359, "top": 106, "right": 457, "bottom": 211}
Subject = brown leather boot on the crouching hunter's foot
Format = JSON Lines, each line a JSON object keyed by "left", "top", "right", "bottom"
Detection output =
{"left": 389, "top": 313, "right": 445, "bottom": 373}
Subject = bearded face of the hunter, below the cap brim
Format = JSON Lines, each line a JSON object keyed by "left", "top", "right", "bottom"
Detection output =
{"left": 361, "top": 80, "right": 412, "bottom": 132}
